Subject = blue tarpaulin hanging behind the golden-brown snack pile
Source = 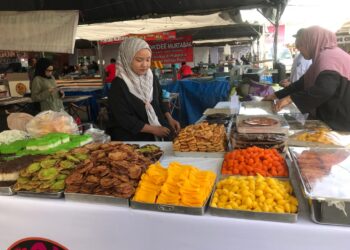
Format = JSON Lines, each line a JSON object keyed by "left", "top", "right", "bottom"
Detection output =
{"left": 162, "top": 79, "right": 230, "bottom": 126}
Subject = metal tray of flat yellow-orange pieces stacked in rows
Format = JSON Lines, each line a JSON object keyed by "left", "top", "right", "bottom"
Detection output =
{"left": 130, "top": 158, "right": 221, "bottom": 215}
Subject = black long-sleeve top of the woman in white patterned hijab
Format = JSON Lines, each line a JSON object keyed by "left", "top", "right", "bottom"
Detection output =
{"left": 107, "top": 77, "right": 170, "bottom": 141}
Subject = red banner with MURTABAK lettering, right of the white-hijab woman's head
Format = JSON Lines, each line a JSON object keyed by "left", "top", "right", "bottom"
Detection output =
{"left": 148, "top": 36, "right": 193, "bottom": 64}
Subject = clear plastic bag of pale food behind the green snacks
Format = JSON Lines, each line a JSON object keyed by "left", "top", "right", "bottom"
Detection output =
{"left": 26, "top": 110, "right": 78, "bottom": 137}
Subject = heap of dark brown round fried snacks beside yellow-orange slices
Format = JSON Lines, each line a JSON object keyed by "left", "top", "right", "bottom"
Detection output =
{"left": 66, "top": 142, "right": 153, "bottom": 198}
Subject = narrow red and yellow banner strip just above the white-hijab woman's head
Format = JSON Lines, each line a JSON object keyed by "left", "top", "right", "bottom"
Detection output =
{"left": 99, "top": 30, "right": 176, "bottom": 45}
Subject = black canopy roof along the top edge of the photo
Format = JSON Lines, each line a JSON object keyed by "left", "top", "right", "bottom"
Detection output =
{"left": 0, "top": 0, "right": 285, "bottom": 24}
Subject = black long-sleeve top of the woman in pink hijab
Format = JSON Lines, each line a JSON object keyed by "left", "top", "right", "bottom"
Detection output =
{"left": 275, "top": 70, "right": 350, "bottom": 131}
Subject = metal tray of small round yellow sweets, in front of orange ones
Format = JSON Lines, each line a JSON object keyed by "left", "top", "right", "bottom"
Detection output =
{"left": 209, "top": 176, "right": 298, "bottom": 223}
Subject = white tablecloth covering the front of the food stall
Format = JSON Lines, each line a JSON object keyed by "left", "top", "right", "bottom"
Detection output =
{"left": 0, "top": 143, "right": 350, "bottom": 250}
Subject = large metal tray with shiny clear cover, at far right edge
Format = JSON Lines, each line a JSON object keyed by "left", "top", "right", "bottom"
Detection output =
{"left": 289, "top": 147, "right": 350, "bottom": 226}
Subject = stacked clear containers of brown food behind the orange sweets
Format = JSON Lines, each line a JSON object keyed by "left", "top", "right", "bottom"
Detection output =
{"left": 231, "top": 115, "right": 289, "bottom": 152}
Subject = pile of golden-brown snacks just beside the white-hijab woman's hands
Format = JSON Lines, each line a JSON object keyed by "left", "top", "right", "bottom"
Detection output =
{"left": 173, "top": 122, "right": 228, "bottom": 157}
